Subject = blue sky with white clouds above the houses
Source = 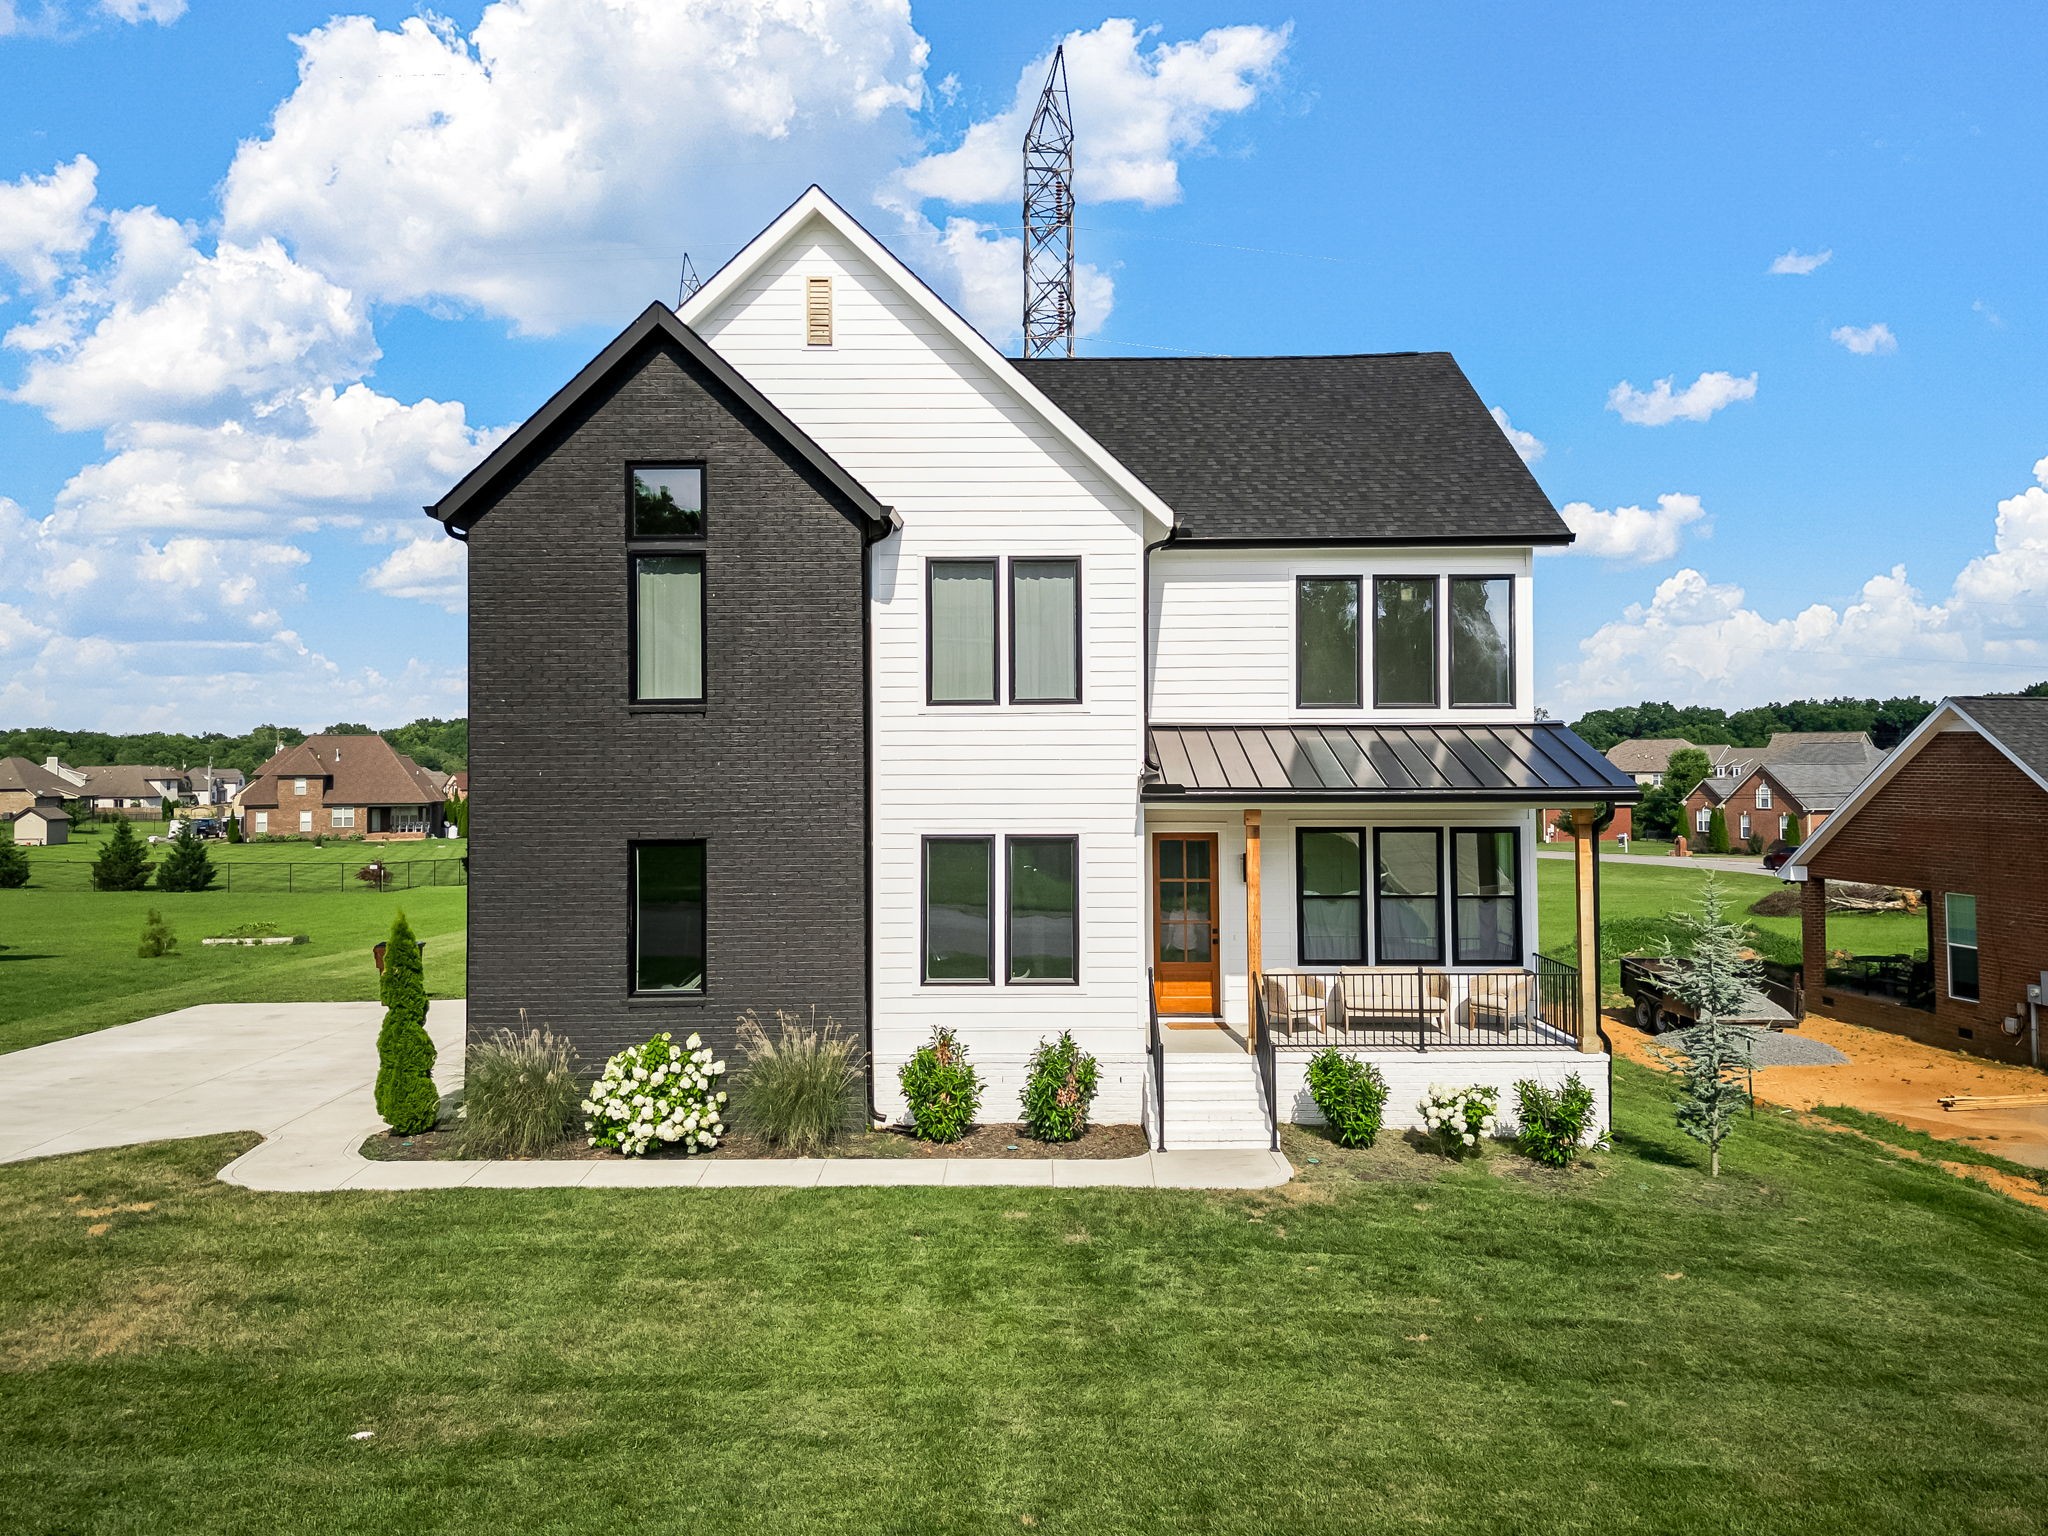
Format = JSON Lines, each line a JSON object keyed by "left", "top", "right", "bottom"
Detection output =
{"left": 0, "top": 0, "right": 2048, "bottom": 729}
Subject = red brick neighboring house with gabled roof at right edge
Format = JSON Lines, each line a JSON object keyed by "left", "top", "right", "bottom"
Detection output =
{"left": 1786, "top": 696, "right": 2048, "bottom": 1065}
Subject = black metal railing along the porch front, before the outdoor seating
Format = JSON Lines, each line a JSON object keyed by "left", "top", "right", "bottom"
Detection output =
{"left": 1260, "top": 956, "right": 1579, "bottom": 1051}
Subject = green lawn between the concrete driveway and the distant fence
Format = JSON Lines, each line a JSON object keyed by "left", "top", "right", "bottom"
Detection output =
{"left": 0, "top": 887, "right": 469, "bottom": 1053}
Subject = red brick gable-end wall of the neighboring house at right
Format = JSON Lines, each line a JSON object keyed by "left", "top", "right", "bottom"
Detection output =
{"left": 1804, "top": 731, "right": 2048, "bottom": 1061}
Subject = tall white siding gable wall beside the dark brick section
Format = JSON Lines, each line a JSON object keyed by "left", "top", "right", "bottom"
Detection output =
{"left": 694, "top": 221, "right": 1145, "bottom": 1120}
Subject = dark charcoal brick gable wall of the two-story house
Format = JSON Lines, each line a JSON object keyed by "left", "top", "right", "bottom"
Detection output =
{"left": 469, "top": 346, "right": 866, "bottom": 1071}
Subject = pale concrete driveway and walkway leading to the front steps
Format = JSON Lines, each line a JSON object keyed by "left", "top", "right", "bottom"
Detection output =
{"left": 0, "top": 1001, "right": 1294, "bottom": 1192}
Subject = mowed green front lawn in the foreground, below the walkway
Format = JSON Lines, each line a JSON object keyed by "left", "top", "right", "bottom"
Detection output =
{"left": 0, "top": 1065, "right": 2048, "bottom": 1536}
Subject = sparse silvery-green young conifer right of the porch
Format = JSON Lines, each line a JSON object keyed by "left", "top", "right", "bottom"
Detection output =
{"left": 1657, "top": 874, "right": 1763, "bottom": 1178}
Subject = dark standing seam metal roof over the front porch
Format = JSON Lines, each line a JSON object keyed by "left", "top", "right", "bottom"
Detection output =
{"left": 1143, "top": 723, "right": 1642, "bottom": 805}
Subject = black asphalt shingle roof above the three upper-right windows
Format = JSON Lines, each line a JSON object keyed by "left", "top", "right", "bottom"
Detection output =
{"left": 1016, "top": 352, "right": 1571, "bottom": 545}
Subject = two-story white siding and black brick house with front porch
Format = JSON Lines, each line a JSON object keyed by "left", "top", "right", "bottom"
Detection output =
{"left": 428, "top": 188, "right": 1638, "bottom": 1147}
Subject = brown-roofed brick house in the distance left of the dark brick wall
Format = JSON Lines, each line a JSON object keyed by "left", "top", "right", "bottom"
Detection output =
{"left": 240, "top": 735, "right": 444, "bottom": 842}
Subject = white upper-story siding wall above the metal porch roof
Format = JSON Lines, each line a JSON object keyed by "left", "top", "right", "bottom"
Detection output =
{"left": 1151, "top": 545, "right": 1536, "bottom": 725}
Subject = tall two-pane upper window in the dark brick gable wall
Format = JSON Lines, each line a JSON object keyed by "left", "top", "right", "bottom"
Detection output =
{"left": 627, "top": 465, "right": 705, "bottom": 705}
